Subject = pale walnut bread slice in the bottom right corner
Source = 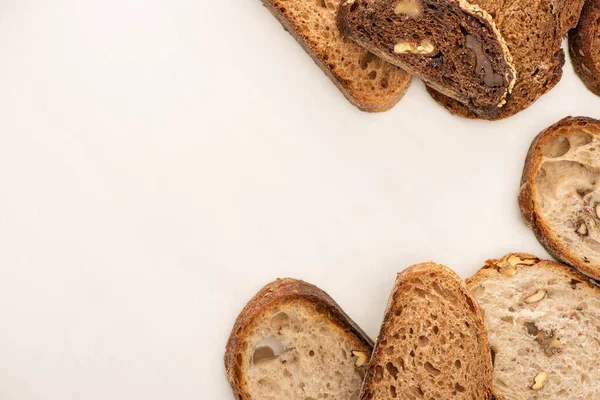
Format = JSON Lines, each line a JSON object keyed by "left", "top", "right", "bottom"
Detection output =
{"left": 467, "top": 254, "right": 600, "bottom": 400}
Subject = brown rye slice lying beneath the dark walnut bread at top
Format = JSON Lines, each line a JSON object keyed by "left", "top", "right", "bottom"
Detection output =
{"left": 427, "top": 0, "right": 583, "bottom": 120}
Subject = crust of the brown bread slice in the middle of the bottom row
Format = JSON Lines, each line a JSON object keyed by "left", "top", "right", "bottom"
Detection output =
{"left": 360, "top": 262, "right": 494, "bottom": 400}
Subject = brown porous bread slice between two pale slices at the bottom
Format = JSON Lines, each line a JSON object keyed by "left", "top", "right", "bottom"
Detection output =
{"left": 360, "top": 263, "right": 492, "bottom": 400}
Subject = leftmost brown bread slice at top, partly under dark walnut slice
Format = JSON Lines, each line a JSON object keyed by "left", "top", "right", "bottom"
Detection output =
{"left": 263, "top": 0, "right": 411, "bottom": 112}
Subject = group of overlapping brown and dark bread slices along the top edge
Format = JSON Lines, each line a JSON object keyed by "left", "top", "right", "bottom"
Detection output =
{"left": 263, "top": 0, "right": 600, "bottom": 120}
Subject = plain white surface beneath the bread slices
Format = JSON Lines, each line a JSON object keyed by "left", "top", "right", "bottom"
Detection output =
{"left": 0, "top": 0, "right": 600, "bottom": 400}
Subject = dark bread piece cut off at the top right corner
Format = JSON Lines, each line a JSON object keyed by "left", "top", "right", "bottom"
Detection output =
{"left": 569, "top": 0, "right": 600, "bottom": 96}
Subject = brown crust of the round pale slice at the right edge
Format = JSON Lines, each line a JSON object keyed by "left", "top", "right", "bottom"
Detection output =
{"left": 518, "top": 117, "right": 600, "bottom": 279}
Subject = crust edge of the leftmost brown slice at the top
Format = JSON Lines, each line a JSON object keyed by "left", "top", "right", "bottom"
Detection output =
{"left": 262, "top": 0, "right": 412, "bottom": 112}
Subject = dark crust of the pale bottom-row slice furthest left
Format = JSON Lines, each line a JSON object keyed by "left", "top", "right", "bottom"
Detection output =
{"left": 224, "top": 278, "right": 373, "bottom": 400}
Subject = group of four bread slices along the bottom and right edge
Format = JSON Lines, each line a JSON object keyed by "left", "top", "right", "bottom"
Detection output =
{"left": 225, "top": 117, "right": 600, "bottom": 400}
